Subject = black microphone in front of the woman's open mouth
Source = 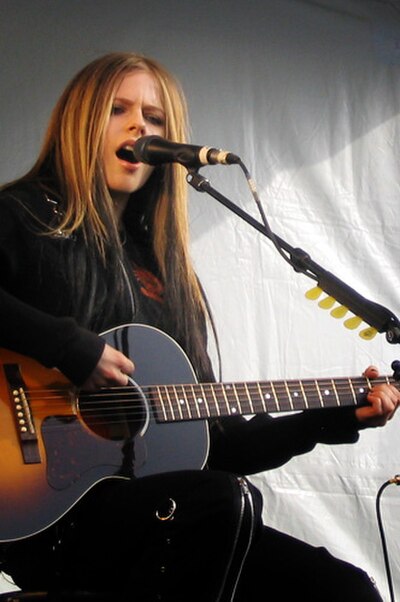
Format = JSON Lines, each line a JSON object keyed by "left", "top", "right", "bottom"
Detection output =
{"left": 133, "top": 136, "right": 240, "bottom": 167}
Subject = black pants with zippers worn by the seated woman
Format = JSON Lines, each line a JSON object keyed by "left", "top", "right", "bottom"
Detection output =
{"left": 3, "top": 471, "right": 382, "bottom": 602}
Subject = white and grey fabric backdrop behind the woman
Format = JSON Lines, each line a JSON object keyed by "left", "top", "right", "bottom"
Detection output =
{"left": 0, "top": 0, "right": 400, "bottom": 600}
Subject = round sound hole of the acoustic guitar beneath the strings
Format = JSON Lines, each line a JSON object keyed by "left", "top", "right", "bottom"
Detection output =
{"left": 78, "top": 381, "right": 148, "bottom": 441}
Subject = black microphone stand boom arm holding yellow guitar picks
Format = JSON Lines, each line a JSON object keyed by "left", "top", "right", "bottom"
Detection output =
{"left": 186, "top": 169, "right": 400, "bottom": 344}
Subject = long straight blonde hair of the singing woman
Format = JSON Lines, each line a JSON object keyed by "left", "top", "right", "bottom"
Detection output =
{"left": 14, "top": 52, "right": 214, "bottom": 372}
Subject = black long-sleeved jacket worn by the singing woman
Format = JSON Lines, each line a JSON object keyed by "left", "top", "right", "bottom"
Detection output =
{"left": 0, "top": 184, "right": 358, "bottom": 474}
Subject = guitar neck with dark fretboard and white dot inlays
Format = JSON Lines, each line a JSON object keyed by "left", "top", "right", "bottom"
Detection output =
{"left": 150, "top": 377, "right": 398, "bottom": 422}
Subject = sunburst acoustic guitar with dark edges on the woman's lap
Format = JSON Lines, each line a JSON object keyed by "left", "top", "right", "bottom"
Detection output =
{"left": 0, "top": 324, "right": 394, "bottom": 542}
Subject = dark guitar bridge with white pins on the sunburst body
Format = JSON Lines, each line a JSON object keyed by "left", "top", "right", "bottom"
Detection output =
{"left": 3, "top": 364, "right": 41, "bottom": 464}
